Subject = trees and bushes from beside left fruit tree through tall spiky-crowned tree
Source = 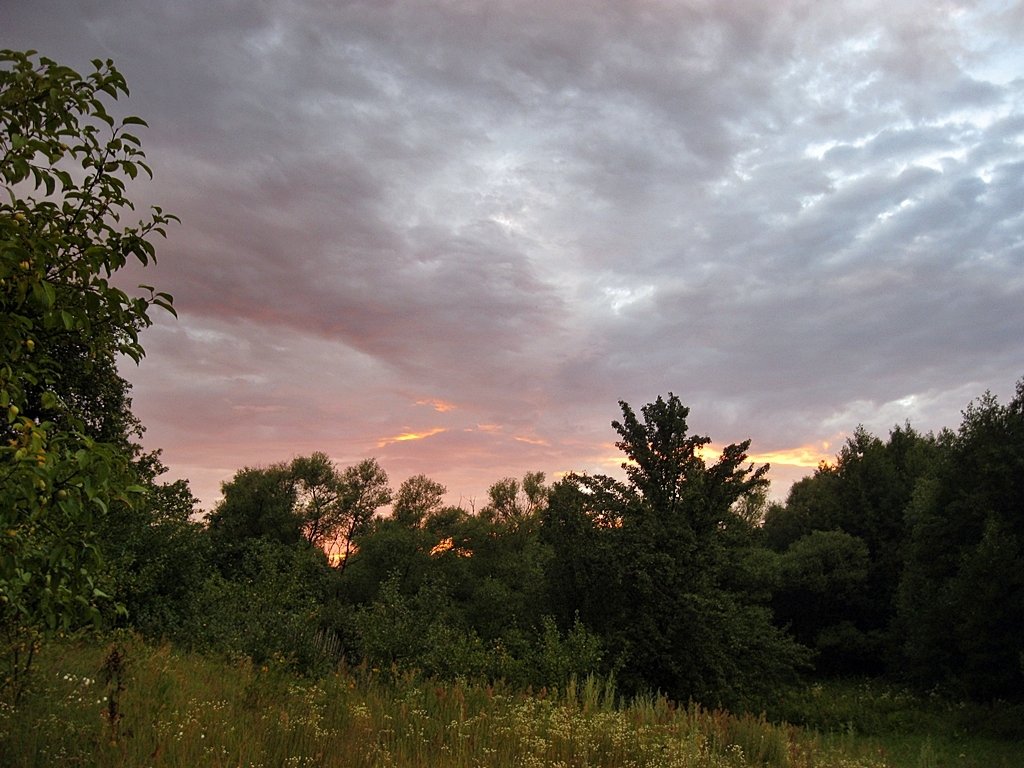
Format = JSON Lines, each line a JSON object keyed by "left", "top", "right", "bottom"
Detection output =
{"left": 86, "top": 395, "right": 809, "bottom": 706}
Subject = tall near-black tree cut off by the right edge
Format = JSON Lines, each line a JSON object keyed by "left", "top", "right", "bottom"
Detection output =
{"left": 898, "top": 379, "right": 1024, "bottom": 698}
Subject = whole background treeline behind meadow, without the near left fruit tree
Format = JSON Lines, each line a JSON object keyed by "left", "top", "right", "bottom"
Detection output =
{"left": 86, "top": 380, "right": 1024, "bottom": 708}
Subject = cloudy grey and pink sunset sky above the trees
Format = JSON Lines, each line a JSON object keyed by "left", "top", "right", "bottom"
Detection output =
{"left": 0, "top": 0, "right": 1024, "bottom": 509}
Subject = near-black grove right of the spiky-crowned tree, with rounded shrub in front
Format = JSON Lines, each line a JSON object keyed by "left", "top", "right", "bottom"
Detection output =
{"left": 761, "top": 380, "right": 1024, "bottom": 698}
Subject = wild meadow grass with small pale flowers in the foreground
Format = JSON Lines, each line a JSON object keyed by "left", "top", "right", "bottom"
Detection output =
{"left": 0, "top": 638, "right": 1024, "bottom": 768}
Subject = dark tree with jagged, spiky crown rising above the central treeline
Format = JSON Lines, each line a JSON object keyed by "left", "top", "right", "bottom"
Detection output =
{"left": 544, "top": 394, "right": 802, "bottom": 705}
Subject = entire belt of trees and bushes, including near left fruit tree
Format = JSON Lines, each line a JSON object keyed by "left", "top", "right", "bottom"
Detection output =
{"left": 0, "top": 51, "right": 1024, "bottom": 711}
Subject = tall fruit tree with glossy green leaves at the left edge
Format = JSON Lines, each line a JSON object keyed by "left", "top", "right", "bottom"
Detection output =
{"left": 0, "top": 50, "right": 174, "bottom": 696}
